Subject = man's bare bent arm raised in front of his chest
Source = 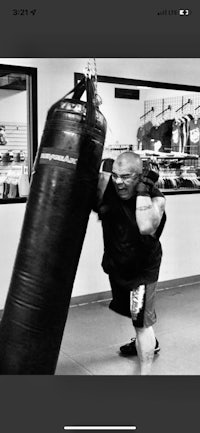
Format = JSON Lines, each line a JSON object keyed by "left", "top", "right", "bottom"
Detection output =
{"left": 136, "top": 195, "right": 165, "bottom": 235}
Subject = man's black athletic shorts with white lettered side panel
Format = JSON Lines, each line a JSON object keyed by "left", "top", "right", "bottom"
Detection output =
{"left": 109, "top": 277, "right": 157, "bottom": 328}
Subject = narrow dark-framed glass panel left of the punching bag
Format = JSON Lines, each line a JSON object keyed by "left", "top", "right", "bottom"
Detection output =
{"left": 0, "top": 67, "right": 37, "bottom": 202}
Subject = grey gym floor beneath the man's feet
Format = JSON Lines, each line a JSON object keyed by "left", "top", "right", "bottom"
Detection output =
{"left": 56, "top": 284, "right": 200, "bottom": 375}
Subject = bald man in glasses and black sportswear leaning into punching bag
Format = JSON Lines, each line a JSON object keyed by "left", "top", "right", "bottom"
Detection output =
{"left": 96, "top": 152, "right": 166, "bottom": 375}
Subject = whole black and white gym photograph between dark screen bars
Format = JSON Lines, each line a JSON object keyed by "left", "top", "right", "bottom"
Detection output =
{"left": 0, "top": 58, "right": 200, "bottom": 375}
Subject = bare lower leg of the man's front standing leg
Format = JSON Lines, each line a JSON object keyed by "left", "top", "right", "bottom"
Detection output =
{"left": 135, "top": 326, "right": 156, "bottom": 376}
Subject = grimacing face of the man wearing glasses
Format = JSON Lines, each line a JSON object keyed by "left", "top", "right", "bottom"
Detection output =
{"left": 112, "top": 161, "right": 138, "bottom": 200}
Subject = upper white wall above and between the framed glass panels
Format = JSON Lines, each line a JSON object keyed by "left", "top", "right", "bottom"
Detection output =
{"left": 0, "top": 58, "right": 200, "bottom": 138}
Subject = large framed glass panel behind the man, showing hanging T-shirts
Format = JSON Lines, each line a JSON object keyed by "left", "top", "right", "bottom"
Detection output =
{"left": 74, "top": 73, "right": 200, "bottom": 193}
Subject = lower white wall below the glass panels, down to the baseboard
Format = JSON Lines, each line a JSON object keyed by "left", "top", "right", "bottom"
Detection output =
{"left": 0, "top": 194, "right": 200, "bottom": 308}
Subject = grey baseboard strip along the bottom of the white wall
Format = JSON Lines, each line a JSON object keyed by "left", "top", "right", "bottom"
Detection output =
{"left": 0, "top": 275, "right": 200, "bottom": 318}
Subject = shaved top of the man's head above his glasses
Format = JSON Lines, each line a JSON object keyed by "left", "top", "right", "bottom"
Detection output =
{"left": 113, "top": 152, "right": 142, "bottom": 174}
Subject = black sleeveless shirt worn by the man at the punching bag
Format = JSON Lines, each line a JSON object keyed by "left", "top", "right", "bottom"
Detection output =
{"left": 99, "top": 179, "right": 166, "bottom": 290}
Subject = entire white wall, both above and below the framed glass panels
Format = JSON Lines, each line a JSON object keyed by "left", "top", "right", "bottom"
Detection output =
{"left": 0, "top": 58, "right": 200, "bottom": 308}
